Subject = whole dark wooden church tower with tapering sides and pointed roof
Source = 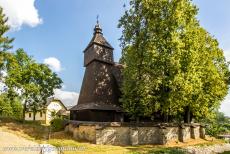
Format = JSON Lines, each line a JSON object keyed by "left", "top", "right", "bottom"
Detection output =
{"left": 70, "top": 22, "right": 123, "bottom": 122}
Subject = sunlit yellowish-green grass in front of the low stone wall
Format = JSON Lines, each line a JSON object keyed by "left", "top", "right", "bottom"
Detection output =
{"left": 0, "top": 121, "right": 223, "bottom": 154}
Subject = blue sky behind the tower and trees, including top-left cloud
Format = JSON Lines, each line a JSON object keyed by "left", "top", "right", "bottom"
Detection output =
{"left": 0, "top": 0, "right": 230, "bottom": 115}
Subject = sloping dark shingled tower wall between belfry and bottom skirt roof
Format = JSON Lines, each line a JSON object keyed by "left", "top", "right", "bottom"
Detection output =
{"left": 78, "top": 61, "right": 118, "bottom": 107}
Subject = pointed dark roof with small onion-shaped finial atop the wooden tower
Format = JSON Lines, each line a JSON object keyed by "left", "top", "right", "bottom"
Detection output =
{"left": 84, "top": 21, "right": 113, "bottom": 52}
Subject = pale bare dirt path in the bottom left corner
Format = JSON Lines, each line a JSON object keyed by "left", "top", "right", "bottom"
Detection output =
{"left": 0, "top": 129, "right": 40, "bottom": 154}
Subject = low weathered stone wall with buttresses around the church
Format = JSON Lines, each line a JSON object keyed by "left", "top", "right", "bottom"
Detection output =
{"left": 65, "top": 121, "right": 205, "bottom": 145}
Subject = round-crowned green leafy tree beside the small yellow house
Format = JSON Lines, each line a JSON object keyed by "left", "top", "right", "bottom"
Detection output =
{"left": 4, "top": 49, "right": 62, "bottom": 119}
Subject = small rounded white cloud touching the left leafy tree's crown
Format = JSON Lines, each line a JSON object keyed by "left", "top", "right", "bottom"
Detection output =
{"left": 43, "top": 57, "right": 62, "bottom": 72}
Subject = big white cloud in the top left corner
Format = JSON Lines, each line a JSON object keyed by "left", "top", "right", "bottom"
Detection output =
{"left": 0, "top": 0, "right": 42, "bottom": 30}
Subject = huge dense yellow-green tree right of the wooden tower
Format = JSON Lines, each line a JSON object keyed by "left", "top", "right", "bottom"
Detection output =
{"left": 119, "top": 0, "right": 229, "bottom": 122}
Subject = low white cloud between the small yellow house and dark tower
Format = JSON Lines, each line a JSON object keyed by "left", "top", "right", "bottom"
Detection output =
{"left": 54, "top": 89, "right": 79, "bottom": 107}
